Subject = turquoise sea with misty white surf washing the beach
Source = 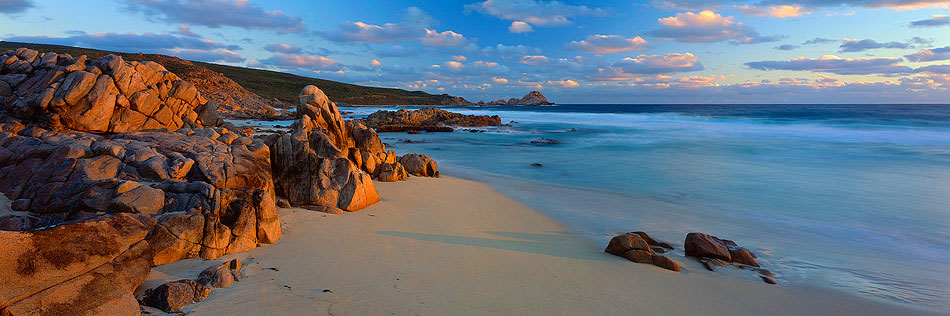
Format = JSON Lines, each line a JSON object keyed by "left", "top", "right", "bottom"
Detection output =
{"left": 341, "top": 105, "right": 950, "bottom": 311}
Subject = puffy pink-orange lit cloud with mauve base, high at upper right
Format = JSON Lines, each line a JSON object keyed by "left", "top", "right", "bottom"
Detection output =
{"left": 650, "top": 10, "right": 780, "bottom": 44}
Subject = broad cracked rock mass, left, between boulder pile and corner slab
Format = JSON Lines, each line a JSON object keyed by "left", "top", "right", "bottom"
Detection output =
{"left": 0, "top": 117, "right": 280, "bottom": 264}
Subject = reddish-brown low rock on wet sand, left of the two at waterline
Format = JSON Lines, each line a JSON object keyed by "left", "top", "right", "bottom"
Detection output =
{"left": 604, "top": 232, "right": 681, "bottom": 271}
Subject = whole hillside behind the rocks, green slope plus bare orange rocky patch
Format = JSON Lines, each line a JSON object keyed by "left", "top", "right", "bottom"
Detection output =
{"left": 0, "top": 41, "right": 472, "bottom": 108}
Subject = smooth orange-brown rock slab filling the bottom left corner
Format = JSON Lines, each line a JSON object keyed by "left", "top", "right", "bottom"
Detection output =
{"left": 0, "top": 213, "right": 155, "bottom": 315}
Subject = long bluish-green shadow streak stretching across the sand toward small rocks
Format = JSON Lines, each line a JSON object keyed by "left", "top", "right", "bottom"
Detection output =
{"left": 376, "top": 231, "right": 611, "bottom": 261}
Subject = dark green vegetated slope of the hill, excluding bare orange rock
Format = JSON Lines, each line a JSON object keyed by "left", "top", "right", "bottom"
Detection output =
{"left": 0, "top": 41, "right": 472, "bottom": 105}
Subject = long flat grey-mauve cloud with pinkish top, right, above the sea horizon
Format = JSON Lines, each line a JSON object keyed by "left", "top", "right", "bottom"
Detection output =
{"left": 744, "top": 55, "right": 915, "bottom": 75}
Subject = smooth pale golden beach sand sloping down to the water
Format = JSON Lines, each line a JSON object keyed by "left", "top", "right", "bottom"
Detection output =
{"left": 140, "top": 177, "right": 935, "bottom": 315}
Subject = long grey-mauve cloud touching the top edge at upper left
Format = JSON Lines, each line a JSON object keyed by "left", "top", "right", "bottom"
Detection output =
{"left": 126, "top": 0, "right": 305, "bottom": 33}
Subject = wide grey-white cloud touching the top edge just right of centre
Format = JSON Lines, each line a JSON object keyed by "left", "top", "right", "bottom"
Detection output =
{"left": 465, "top": 0, "right": 610, "bottom": 27}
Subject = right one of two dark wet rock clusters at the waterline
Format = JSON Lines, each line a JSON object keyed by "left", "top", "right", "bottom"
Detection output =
{"left": 684, "top": 233, "right": 776, "bottom": 284}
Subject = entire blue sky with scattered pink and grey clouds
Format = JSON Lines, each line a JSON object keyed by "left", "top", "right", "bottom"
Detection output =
{"left": 0, "top": 0, "right": 950, "bottom": 103}
